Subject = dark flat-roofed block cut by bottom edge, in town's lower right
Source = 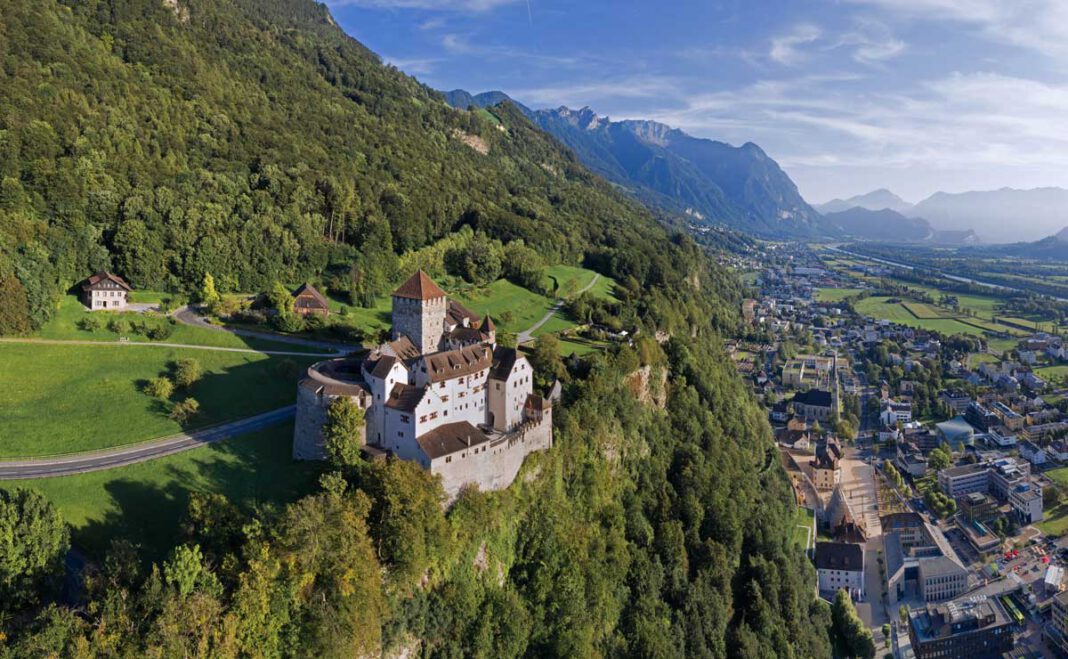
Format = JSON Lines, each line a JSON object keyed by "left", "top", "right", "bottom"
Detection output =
{"left": 909, "top": 595, "right": 1015, "bottom": 659}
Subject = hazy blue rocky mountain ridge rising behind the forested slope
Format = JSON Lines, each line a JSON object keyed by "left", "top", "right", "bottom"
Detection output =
{"left": 444, "top": 90, "right": 820, "bottom": 236}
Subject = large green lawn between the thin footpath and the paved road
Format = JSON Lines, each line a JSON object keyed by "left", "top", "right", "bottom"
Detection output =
{"left": 0, "top": 344, "right": 315, "bottom": 457}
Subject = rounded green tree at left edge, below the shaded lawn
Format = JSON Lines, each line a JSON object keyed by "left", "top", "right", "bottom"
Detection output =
{"left": 0, "top": 488, "right": 70, "bottom": 613}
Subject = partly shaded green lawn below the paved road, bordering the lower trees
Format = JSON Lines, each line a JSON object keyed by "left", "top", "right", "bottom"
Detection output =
{"left": 0, "top": 423, "right": 320, "bottom": 561}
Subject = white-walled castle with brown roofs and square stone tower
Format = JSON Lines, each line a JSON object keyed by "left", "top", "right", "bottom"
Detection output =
{"left": 293, "top": 270, "right": 552, "bottom": 498}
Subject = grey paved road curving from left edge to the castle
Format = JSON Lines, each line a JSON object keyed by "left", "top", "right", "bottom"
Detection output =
{"left": 0, "top": 405, "right": 297, "bottom": 481}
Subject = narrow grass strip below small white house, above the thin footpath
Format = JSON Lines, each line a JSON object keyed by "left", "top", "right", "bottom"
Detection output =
{"left": 36, "top": 294, "right": 323, "bottom": 352}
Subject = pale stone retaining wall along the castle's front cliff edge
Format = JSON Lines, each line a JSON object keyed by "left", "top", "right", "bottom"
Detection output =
{"left": 430, "top": 409, "right": 552, "bottom": 501}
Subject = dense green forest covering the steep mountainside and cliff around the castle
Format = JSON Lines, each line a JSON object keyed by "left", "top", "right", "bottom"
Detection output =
{"left": 0, "top": 0, "right": 832, "bottom": 657}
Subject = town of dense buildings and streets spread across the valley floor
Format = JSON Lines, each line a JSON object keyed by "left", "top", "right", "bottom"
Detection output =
{"left": 731, "top": 244, "right": 1068, "bottom": 658}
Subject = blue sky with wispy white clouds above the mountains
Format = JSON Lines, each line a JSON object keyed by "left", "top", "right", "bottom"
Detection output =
{"left": 327, "top": 0, "right": 1068, "bottom": 203}
